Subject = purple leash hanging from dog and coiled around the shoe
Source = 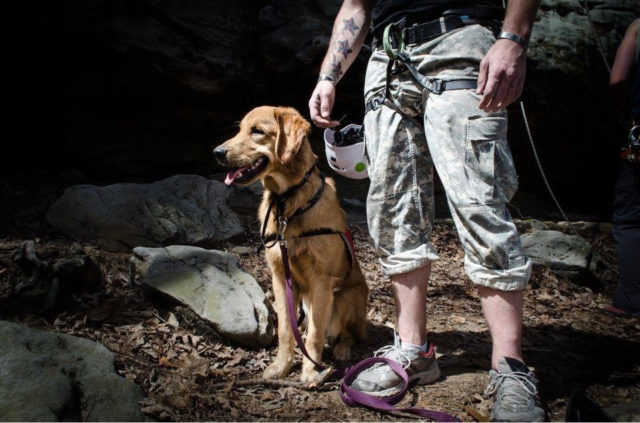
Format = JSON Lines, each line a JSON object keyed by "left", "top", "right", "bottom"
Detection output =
{"left": 280, "top": 242, "right": 459, "bottom": 422}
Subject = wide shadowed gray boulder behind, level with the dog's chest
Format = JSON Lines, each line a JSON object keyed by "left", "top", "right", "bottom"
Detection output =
{"left": 46, "top": 175, "right": 244, "bottom": 251}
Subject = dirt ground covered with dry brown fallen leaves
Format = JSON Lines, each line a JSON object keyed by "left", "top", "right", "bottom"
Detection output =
{"left": 0, "top": 181, "right": 640, "bottom": 421}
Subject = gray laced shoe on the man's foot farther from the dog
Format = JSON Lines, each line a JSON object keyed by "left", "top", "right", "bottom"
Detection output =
{"left": 484, "top": 357, "right": 546, "bottom": 422}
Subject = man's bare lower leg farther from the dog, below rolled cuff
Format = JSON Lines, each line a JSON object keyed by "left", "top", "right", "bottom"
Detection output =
{"left": 478, "top": 286, "right": 524, "bottom": 370}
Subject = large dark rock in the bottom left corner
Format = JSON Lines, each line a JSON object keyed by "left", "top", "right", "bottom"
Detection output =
{"left": 0, "top": 321, "right": 147, "bottom": 421}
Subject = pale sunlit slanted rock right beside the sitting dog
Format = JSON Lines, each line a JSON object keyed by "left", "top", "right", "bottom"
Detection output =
{"left": 133, "top": 245, "right": 274, "bottom": 347}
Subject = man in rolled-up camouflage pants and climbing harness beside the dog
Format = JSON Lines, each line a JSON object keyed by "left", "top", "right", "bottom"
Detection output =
{"left": 309, "top": 0, "right": 546, "bottom": 421}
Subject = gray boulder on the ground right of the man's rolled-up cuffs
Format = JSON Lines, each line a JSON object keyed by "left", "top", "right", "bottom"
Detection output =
{"left": 521, "top": 230, "right": 596, "bottom": 275}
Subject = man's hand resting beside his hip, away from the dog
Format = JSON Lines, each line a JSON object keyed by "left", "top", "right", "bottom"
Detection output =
{"left": 476, "top": 39, "right": 527, "bottom": 112}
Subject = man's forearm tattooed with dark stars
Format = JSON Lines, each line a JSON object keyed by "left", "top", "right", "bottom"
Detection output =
{"left": 320, "top": 0, "right": 370, "bottom": 85}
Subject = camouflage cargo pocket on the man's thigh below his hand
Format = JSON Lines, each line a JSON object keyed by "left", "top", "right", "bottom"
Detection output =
{"left": 465, "top": 112, "right": 518, "bottom": 204}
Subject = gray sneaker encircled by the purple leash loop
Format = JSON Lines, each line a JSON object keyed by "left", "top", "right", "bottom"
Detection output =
{"left": 351, "top": 337, "right": 440, "bottom": 397}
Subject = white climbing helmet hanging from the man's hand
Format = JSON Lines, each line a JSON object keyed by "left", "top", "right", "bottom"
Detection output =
{"left": 324, "top": 124, "right": 369, "bottom": 179}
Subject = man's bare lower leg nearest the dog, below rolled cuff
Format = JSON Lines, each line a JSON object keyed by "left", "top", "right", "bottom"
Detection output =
{"left": 391, "top": 264, "right": 431, "bottom": 345}
